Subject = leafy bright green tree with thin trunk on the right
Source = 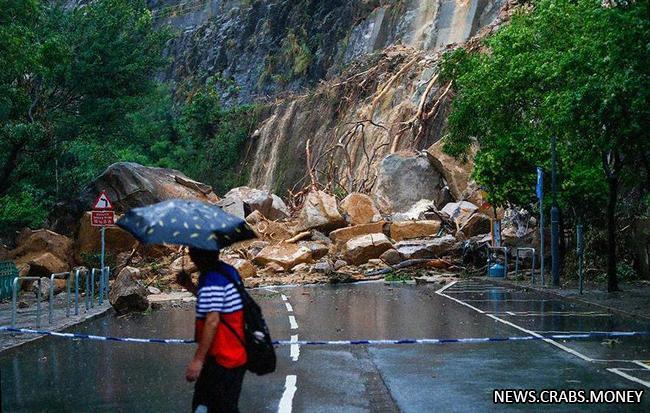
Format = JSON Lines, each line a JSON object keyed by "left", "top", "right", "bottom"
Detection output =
{"left": 442, "top": 0, "right": 650, "bottom": 290}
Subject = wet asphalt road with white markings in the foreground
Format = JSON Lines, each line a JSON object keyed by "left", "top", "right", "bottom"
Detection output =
{"left": 0, "top": 281, "right": 650, "bottom": 412}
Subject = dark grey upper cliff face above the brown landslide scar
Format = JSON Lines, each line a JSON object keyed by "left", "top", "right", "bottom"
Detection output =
{"left": 148, "top": 0, "right": 503, "bottom": 103}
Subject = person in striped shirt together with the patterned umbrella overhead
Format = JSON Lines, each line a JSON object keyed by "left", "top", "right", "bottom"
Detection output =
{"left": 117, "top": 200, "right": 255, "bottom": 413}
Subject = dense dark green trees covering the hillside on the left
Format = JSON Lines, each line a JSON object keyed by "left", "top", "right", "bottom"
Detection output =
{"left": 0, "top": 0, "right": 254, "bottom": 234}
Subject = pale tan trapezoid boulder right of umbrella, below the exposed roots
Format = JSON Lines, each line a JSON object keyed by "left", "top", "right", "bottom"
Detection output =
{"left": 296, "top": 191, "right": 345, "bottom": 232}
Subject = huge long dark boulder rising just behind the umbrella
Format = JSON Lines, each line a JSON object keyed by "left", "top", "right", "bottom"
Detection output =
{"left": 48, "top": 162, "right": 219, "bottom": 234}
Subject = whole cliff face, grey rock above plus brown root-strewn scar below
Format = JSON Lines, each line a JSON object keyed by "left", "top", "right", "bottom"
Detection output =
{"left": 148, "top": 0, "right": 507, "bottom": 195}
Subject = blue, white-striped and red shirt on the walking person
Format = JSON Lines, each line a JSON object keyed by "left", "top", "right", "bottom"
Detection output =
{"left": 195, "top": 263, "right": 246, "bottom": 368}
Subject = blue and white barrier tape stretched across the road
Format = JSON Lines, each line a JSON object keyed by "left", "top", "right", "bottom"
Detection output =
{"left": 0, "top": 326, "right": 650, "bottom": 346}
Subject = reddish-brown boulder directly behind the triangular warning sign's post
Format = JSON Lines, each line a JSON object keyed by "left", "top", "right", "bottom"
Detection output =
{"left": 74, "top": 212, "right": 137, "bottom": 264}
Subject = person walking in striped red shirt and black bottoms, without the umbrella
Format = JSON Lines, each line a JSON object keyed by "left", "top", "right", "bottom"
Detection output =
{"left": 177, "top": 248, "right": 247, "bottom": 413}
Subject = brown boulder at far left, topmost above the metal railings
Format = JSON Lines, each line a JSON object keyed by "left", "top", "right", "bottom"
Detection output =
{"left": 9, "top": 229, "right": 73, "bottom": 265}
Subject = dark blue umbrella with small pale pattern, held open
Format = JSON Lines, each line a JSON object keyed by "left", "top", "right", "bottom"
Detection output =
{"left": 117, "top": 199, "right": 255, "bottom": 251}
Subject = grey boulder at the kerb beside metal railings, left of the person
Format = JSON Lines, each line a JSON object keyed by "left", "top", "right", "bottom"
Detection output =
{"left": 108, "top": 267, "right": 149, "bottom": 314}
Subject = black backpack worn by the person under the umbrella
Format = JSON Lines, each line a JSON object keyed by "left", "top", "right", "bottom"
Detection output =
{"left": 222, "top": 271, "right": 276, "bottom": 376}
